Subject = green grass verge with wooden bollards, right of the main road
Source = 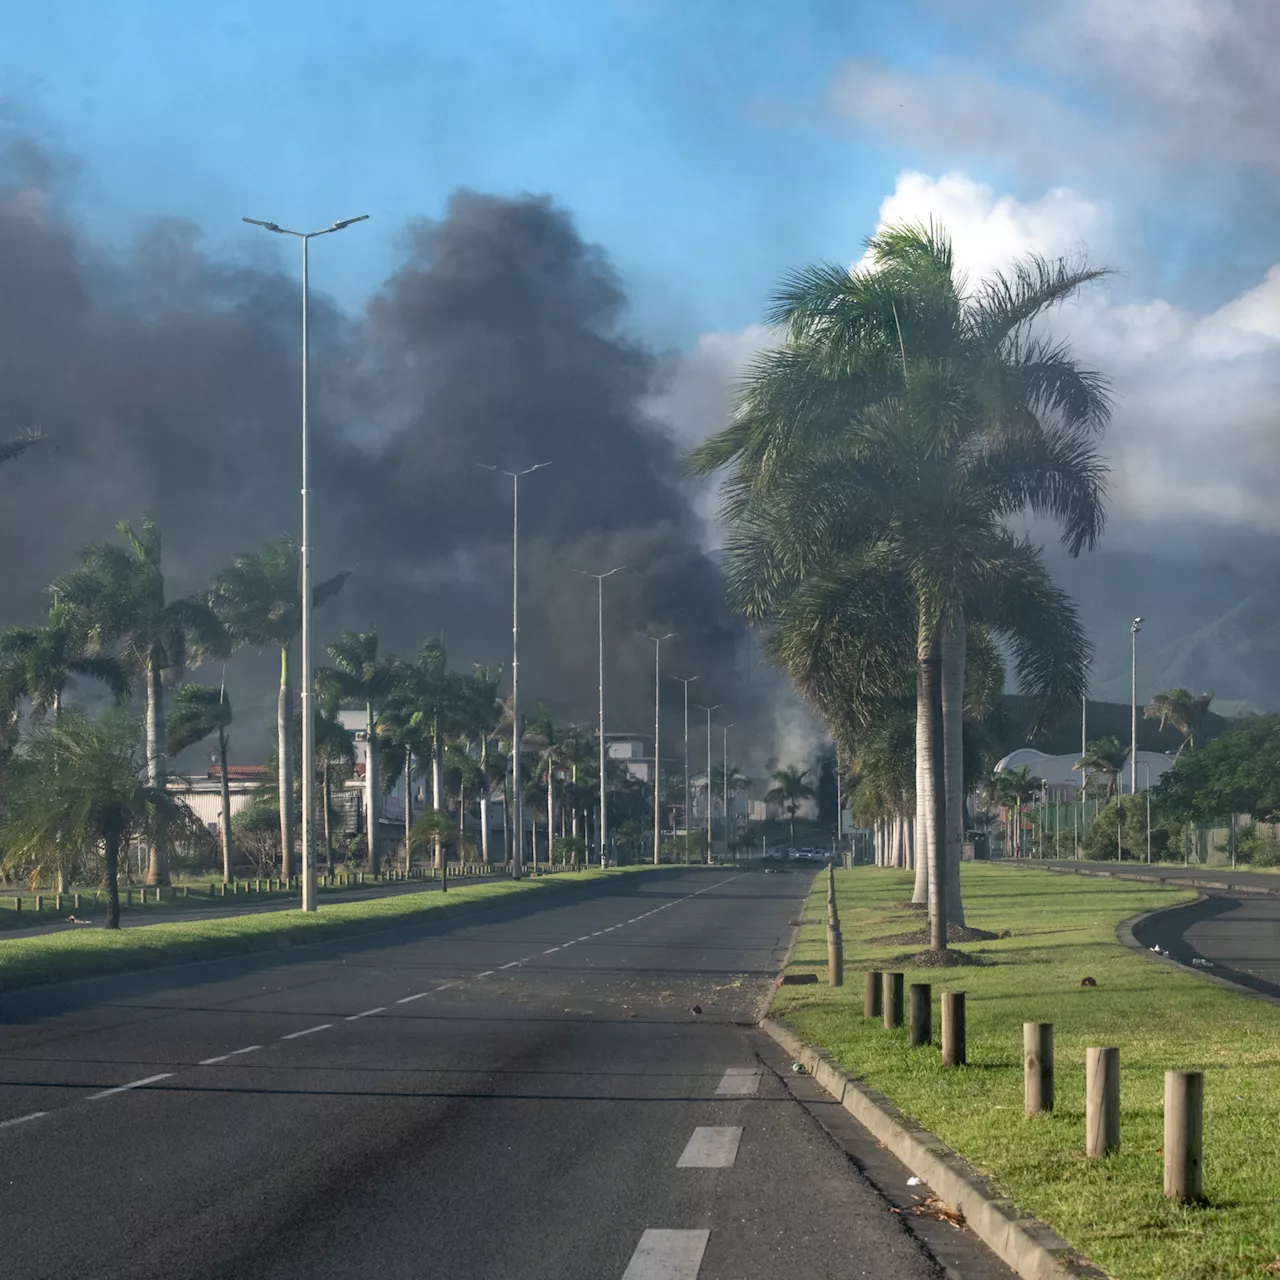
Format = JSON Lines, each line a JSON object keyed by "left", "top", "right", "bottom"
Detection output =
{"left": 773, "top": 865, "right": 1280, "bottom": 1280}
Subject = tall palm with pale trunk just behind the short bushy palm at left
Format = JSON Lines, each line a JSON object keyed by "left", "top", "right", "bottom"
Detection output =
{"left": 52, "top": 520, "right": 229, "bottom": 884}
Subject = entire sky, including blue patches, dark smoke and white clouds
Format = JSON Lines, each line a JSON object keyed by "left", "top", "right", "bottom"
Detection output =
{"left": 0, "top": 0, "right": 1280, "bottom": 754}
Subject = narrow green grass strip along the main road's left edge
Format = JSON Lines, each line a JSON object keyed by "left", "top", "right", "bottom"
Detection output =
{"left": 0, "top": 867, "right": 660, "bottom": 991}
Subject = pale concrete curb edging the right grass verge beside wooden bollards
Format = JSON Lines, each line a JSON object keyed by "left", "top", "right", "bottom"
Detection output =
{"left": 760, "top": 1016, "right": 1106, "bottom": 1280}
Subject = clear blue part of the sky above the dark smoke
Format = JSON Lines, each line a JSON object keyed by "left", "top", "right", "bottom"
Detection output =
{"left": 0, "top": 0, "right": 1013, "bottom": 344}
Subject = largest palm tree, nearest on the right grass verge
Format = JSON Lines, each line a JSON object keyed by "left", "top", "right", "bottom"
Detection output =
{"left": 691, "top": 227, "right": 1110, "bottom": 950}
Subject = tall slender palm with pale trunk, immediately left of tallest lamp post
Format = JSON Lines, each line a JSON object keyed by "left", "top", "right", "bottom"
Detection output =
{"left": 209, "top": 536, "right": 351, "bottom": 881}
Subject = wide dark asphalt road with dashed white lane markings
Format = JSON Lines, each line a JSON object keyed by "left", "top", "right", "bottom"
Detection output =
{"left": 0, "top": 868, "right": 988, "bottom": 1280}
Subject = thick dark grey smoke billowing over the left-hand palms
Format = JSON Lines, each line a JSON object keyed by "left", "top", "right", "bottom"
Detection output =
{"left": 0, "top": 145, "right": 750, "bottom": 756}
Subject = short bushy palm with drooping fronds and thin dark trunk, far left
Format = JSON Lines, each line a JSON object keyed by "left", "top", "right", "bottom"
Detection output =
{"left": 3, "top": 709, "right": 207, "bottom": 929}
